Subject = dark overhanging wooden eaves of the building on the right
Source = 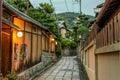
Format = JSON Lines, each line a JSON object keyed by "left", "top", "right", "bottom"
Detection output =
{"left": 95, "top": 0, "right": 120, "bottom": 27}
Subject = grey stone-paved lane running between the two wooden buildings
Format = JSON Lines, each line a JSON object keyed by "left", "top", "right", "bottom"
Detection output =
{"left": 34, "top": 57, "right": 80, "bottom": 80}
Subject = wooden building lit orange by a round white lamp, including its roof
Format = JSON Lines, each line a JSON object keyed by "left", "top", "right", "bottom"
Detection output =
{"left": 1, "top": 2, "right": 55, "bottom": 75}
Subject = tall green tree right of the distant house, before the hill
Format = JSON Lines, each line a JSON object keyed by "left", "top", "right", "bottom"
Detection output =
{"left": 71, "top": 14, "right": 89, "bottom": 42}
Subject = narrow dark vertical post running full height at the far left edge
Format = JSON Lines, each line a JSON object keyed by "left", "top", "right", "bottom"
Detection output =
{"left": 0, "top": 0, "right": 2, "bottom": 80}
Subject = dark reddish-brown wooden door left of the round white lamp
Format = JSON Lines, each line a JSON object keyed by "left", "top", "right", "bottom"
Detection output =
{"left": 2, "top": 29, "right": 12, "bottom": 76}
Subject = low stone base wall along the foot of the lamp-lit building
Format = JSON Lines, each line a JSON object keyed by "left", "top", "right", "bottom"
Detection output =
{"left": 17, "top": 52, "right": 53, "bottom": 80}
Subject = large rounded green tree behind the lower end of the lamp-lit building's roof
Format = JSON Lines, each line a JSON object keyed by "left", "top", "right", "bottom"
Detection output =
{"left": 28, "top": 3, "right": 59, "bottom": 36}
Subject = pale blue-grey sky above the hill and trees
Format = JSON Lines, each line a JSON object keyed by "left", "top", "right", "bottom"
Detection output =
{"left": 30, "top": 0, "right": 105, "bottom": 16}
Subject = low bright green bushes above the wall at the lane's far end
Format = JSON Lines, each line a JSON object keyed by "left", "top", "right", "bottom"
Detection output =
{"left": 61, "top": 38, "right": 77, "bottom": 49}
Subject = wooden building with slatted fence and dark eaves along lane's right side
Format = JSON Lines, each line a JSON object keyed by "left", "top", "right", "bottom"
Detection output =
{"left": 80, "top": 0, "right": 120, "bottom": 80}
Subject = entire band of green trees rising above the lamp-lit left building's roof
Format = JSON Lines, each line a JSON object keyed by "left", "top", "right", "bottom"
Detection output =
{"left": 6, "top": 0, "right": 59, "bottom": 39}
